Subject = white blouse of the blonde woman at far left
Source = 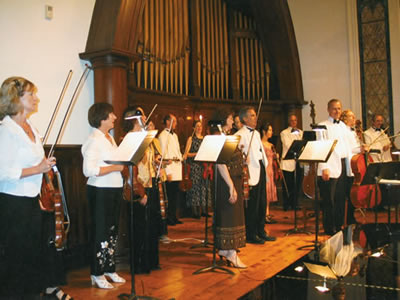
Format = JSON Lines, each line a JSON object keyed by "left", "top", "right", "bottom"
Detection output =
{"left": 0, "top": 116, "right": 44, "bottom": 197}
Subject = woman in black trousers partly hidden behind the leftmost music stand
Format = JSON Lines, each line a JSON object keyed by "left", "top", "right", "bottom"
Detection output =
{"left": 122, "top": 107, "right": 161, "bottom": 274}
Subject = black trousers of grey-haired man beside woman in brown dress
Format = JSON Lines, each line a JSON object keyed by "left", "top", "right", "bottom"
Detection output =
{"left": 245, "top": 160, "right": 267, "bottom": 239}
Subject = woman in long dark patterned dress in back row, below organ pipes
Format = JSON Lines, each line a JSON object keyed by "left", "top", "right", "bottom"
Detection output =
{"left": 183, "top": 120, "right": 209, "bottom": 219}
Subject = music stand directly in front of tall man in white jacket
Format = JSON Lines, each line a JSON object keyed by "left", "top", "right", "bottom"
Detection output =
{"left": 297, "top": 140, "right": 337, "bottom": 255}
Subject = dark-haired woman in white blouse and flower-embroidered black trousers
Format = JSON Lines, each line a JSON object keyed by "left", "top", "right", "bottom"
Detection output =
{"left": 82, "top": 103, "right": 125, "bottom": 289}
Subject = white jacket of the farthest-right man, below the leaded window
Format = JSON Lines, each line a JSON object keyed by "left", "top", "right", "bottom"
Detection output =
{"left": 364, "top": 127, "right": 392, "bottom": 162}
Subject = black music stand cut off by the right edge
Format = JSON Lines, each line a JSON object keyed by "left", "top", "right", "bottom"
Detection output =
{"left": 361, "top": 161, "right": 400, "bottom": 226}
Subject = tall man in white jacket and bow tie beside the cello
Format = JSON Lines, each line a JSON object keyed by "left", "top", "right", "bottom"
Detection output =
{"left": 318, "top": 99, "right": 351, "bottom": 235}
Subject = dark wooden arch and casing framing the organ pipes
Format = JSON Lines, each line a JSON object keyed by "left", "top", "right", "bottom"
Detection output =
{"left": 80, "top": 0, "right": 304, "bottom": 143}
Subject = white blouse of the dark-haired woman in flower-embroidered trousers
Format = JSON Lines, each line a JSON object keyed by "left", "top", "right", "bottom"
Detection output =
{"left": 82, "top": 128, "right": 123, "bottom": 188}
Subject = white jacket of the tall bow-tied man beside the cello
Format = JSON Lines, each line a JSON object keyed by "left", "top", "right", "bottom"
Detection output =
{"left": 318, "top": 117, "right": 351, "bottom": 178}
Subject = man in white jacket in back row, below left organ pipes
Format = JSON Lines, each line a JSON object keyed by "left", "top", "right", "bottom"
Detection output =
{"left": 158, "top": 114, "right": 182, "bottom": 226}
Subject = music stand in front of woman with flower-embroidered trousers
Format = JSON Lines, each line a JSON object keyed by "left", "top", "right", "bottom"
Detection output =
{"left": 104, "top": 130, "right": 158, "bottom": 300}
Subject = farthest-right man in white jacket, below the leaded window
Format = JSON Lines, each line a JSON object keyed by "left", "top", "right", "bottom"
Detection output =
{"left": 364, "top": 114, "right": 392, "bottom": 162}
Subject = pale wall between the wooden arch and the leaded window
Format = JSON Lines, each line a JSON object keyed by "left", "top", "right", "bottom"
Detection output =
{"left": 288, "top": 0, "right": 351, "bottom": 125}
